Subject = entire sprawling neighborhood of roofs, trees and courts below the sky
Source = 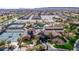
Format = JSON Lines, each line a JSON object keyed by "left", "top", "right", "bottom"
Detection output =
{"left": 0, "top": 7, "right": 79, "bottom": 51}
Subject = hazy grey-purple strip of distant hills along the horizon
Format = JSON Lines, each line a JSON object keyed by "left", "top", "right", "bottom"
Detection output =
{"left": 0, "top": 7, "right": 79, "bottom": 12}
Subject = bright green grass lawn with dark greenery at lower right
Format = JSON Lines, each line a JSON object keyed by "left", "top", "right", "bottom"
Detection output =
{"left": 54, "top": 36, "right": 79, "bottom": 50}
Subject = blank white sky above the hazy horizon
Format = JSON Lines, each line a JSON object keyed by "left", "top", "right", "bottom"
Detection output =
{"left": 0, "top": 0, "right": 79, "bottom": 9}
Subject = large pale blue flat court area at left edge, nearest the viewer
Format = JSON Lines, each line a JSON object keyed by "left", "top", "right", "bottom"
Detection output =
{"left": 0, "top": 32, "right": 21, "bottom": 41}
